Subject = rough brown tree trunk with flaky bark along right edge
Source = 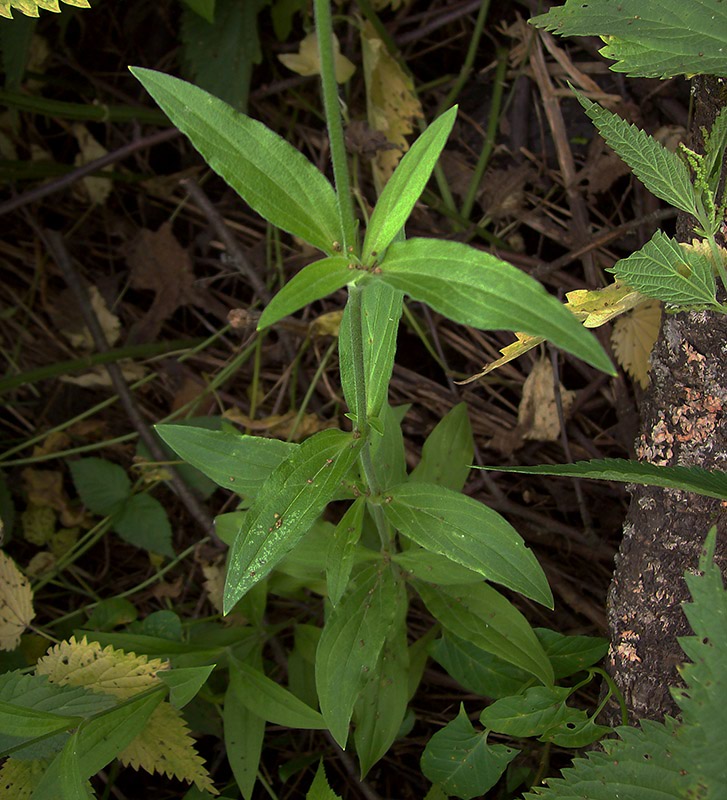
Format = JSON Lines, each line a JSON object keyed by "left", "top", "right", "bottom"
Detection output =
{"left": 606, "top": 77, "right": 727, "bottom": 724}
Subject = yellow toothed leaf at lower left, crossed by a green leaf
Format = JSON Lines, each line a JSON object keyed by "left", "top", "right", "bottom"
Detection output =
{"left": 36, "top": 637, "right": 217, "bottom": 794}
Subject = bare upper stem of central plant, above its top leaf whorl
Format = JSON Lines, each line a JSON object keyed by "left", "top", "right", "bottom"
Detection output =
{"left": 314, "top": 0, "right": 357, "bottom": 252}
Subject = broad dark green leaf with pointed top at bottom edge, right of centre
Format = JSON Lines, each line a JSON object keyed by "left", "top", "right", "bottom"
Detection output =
{"left": 422, "top": 705, "right": 518, "bottom": 800}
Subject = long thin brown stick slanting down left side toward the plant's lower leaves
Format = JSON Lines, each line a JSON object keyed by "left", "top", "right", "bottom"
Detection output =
{"left": 42, "top": 230, "right": 222, "bottom": 545}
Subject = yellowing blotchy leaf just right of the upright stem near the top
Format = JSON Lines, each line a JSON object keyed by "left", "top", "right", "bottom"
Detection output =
{"left": 361, "top": 22, "right": 424, "bottom": 193}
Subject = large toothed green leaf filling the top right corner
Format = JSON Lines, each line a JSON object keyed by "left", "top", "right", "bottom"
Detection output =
{"left": 530, "top": 0, "right": 727, "bottom": 78}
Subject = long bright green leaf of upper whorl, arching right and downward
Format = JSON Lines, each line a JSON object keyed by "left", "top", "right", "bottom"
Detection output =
{"left": 381, "top": 239, "right": 615, "bottom": 375}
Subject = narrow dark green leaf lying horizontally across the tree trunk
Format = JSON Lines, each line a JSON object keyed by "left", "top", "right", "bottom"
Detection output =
{"left": 475, "top": 458, "right": 727, "bottom": 500}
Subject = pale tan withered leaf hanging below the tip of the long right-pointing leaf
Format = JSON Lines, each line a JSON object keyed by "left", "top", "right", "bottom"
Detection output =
{"left": 518, "top": 359, "right": 576, "bottom": 442}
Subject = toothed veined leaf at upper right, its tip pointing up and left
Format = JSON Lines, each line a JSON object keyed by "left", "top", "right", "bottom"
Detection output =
{"left": 574, "top": 90, "right": 695, "bottom": 214}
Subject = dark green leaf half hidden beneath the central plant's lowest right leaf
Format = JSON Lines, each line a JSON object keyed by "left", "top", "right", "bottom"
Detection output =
{"left": 432, "top": 633, "right": 532, "bottom": 699}
